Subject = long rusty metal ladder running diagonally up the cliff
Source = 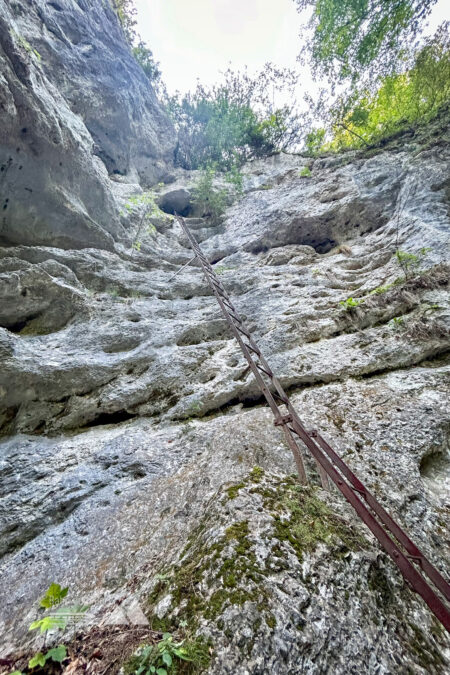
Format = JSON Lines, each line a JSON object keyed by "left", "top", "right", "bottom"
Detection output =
{"left": 177, "top": 216, "right": 450, "bottom": 632}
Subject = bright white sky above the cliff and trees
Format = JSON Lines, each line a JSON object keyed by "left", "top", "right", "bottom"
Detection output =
{"left": 135, "top": 0, "right": 450, "bottom": 98}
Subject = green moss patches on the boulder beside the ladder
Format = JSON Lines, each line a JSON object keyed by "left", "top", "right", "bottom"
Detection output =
{"left": 149, "top": 467, "right": 364, "bottom": 635}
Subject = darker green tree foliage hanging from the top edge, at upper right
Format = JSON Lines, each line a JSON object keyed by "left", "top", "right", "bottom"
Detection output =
{"left": 295, "top": 0, "right": 436, "bottom": 84}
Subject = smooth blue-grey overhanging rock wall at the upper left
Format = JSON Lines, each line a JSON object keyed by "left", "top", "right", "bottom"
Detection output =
{"left": 0, "top": 0, "right": 175, "bottom": 249}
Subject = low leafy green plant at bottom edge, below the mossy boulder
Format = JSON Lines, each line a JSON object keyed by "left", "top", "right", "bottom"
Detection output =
{"left": 124, "top": 633, "right": 210, "bottom": 675}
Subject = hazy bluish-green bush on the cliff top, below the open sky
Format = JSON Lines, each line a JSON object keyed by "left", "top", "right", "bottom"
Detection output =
{"left": 166, "top": 64, "right": 300, "bottom": 171}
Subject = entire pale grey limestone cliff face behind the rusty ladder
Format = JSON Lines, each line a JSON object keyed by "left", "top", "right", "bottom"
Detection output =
{"left": 0, "top": 5, "right": 450, "bottom": 675}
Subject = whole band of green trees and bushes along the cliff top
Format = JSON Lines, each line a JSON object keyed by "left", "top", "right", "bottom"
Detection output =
{"left": 110, "top": 0, "right": 450, "bottom": 166}
